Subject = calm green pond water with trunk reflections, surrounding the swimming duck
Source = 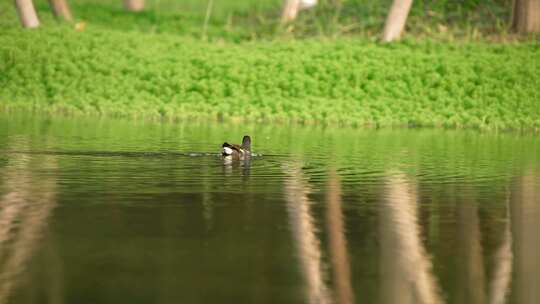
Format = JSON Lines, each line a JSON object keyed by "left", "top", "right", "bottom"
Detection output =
{"left": 0, "top": 114, "right": 540, "bottom": 304}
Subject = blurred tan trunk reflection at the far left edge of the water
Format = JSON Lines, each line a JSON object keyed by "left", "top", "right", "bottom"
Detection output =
{"left": 0, "top": 141, "right": 58, "bottom": 303}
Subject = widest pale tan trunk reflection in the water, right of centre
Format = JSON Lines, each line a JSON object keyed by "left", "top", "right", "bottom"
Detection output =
{"left": 379, "top": 172, "right": 442, "bottom": 304}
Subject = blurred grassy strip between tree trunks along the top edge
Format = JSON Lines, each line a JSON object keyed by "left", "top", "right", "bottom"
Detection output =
{"left": 0, "top": 0, "right": 527, "bottom": 42}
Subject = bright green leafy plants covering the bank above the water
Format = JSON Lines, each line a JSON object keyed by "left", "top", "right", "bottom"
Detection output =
{"left": 0, "top": 1, "right": 540, "bottom": 129}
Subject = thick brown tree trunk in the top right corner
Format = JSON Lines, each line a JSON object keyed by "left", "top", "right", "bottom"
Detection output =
{"left": 512, "top": 0, "right": 540, "bottom": 33}
